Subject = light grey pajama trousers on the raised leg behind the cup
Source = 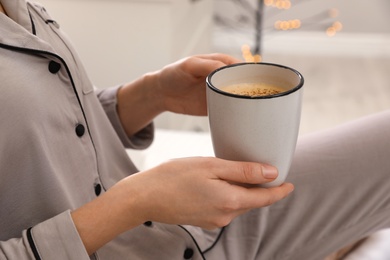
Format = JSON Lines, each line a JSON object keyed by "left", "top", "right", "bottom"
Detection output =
{"left": 205, "top": 111, "right": 390, "bottom": 260}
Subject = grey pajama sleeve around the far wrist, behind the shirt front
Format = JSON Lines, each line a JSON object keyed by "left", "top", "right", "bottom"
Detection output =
{"left": 95, "top": 86, "right": 154, "bottom": 149}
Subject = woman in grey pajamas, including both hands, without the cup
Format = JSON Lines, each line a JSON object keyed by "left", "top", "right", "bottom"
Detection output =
{"left": 0, "top": 0, "right": 390, "bottom": 259}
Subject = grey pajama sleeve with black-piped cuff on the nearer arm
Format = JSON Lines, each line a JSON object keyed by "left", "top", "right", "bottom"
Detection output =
{"left": 0, "top": 210, "right": 90, "bottom": 260}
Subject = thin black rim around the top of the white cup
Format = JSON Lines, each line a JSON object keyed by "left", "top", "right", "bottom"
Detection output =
{"left": 206, "top": 62, "right": 304, "bottom": 99}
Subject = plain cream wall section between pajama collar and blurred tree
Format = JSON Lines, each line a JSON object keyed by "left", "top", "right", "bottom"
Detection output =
{"left": 39, "top": 0, "right": 212, "bottom": 88}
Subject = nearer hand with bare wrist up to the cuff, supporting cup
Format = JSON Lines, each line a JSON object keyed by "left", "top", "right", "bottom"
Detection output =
{"left": 72, "top": 157, "right": 293, "bottom": 254}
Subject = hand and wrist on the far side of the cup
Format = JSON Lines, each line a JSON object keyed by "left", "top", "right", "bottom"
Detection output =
{"left": 117, "top": 54, "right": 239, "bottom": 136}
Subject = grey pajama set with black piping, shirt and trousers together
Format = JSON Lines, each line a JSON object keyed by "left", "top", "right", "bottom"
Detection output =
{"left": 0, "top": 0, "right": 390, "bottom": 260}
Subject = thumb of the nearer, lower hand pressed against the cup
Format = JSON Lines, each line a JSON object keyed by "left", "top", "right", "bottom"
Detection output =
{"left": 216, "top": 160, "right": 278, "bottom": 184}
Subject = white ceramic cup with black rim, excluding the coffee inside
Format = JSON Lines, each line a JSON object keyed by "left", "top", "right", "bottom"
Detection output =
{"left": 206, "top": 63, "right": 304, "bottom": 187}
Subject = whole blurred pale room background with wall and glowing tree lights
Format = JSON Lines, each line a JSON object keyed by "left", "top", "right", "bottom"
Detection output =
{"left": 40, "top": 0, "right": 390, "bottom": 134}
